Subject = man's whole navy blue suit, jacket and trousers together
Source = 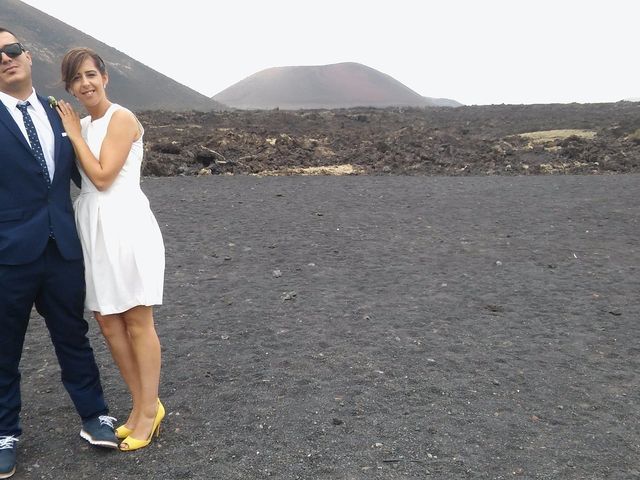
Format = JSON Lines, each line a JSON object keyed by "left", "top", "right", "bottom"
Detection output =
{"left": 0, "top": 93, "right": 107, "bottom": 436}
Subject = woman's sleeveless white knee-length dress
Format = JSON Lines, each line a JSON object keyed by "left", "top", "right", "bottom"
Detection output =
{"left": 74, "top": 104, "right": 164, "bottom": 315}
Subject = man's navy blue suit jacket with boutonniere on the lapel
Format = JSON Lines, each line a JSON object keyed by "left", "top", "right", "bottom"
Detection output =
{"left": 0, "top": 95, "right": 82, "bottom": 265}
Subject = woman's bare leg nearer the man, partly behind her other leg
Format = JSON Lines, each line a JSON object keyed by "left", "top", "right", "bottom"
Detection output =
{"left": 94, "top": 312, "right": 141, "bottom": 429}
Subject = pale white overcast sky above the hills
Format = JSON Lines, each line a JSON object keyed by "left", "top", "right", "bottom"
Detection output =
{"left": 17, "top": 0, "right": 640, "bottom": 105}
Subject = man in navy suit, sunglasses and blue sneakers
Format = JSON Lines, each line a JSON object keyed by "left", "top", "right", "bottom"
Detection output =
{"left": 0, "top": 27, "right": 118, "bottom": 479}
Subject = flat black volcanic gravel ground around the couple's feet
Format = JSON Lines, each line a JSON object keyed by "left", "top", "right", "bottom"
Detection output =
{"left": 14, "top": 175, "right": 640, "bottom": 480}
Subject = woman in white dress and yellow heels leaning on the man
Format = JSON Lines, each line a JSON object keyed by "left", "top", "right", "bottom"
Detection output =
{"left": 57, "top": 48, "right": 165, "bottom": 451}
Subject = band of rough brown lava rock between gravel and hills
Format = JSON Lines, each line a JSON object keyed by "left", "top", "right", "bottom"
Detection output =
{"left": 139, "top": 102, "right": 640, "bottom": 176}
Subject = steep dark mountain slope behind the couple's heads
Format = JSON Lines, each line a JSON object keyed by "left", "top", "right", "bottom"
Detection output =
{"left": 0, "top": 0, "right": 224, "bottom": 111}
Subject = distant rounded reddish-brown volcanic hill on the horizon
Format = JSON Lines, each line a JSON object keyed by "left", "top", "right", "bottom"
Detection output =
{"left": 212, "top": 62, "right": 462, "bottom": 110}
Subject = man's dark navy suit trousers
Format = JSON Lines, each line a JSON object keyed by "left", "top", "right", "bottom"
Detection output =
{"left": 0, "top": 239, "right": 108, "bottom": 436}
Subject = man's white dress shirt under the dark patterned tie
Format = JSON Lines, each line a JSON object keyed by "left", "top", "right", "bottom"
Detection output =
{"left": 0, "top": 90, "right": 58, "bottom": 181}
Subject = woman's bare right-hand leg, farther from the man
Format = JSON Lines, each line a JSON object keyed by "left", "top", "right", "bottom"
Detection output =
{"left": 120, "top": 305, "right": 161, "bottom": 440}
